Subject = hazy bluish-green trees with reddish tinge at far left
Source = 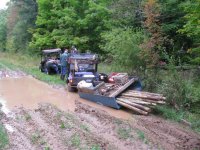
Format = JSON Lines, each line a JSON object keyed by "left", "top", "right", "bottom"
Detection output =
{"left": 6, "top": 0, "right": 37, "bottom": 53}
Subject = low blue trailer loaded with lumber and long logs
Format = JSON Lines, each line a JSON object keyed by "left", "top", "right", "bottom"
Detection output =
{"left": 78, "top": 73, "right": 166, "bottom": 115}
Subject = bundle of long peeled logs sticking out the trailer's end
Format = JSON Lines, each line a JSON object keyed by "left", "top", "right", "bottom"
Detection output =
{"left": 117, "top": 90, "right": 166, "bottom": 115}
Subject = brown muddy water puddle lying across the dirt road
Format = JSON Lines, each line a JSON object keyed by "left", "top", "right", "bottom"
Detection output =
{"left": 0, "top": 76, "right": 132, "bottom": 119}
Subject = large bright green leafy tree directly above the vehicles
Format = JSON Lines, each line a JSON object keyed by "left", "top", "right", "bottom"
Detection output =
{"left": 30, "top": 0, "right": 109, "bottom": 52}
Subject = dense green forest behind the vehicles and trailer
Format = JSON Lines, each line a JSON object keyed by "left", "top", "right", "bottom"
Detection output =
{"left": 0, "top": 0, "right": 200, "bottom": 126}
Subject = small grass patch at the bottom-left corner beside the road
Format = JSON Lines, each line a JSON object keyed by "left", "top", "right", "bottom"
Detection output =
{"left": 0, "top": 124, "right": 9, "bottom": 150}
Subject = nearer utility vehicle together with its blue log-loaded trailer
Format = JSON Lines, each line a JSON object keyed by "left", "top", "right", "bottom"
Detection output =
{"left": 67, "top": 53, "right": 165, "bottom": 115}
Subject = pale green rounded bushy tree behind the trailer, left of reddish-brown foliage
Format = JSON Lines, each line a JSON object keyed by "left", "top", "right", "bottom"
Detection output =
{"left": 102, "top": 28, "right": 146, "bottom": 72}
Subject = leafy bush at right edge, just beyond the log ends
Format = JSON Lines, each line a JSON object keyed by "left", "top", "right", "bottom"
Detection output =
{"left": 157, "top": 62, "right": 200, "bottom": 110}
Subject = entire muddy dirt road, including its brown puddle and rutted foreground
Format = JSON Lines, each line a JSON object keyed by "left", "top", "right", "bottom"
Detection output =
{"left": 0, "top": 70, "right": 200, "bottom": 150}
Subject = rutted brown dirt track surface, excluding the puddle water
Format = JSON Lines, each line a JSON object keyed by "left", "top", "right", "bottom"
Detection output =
{"left": 0, "top": 71, "right": 200, "bottom": 150}
